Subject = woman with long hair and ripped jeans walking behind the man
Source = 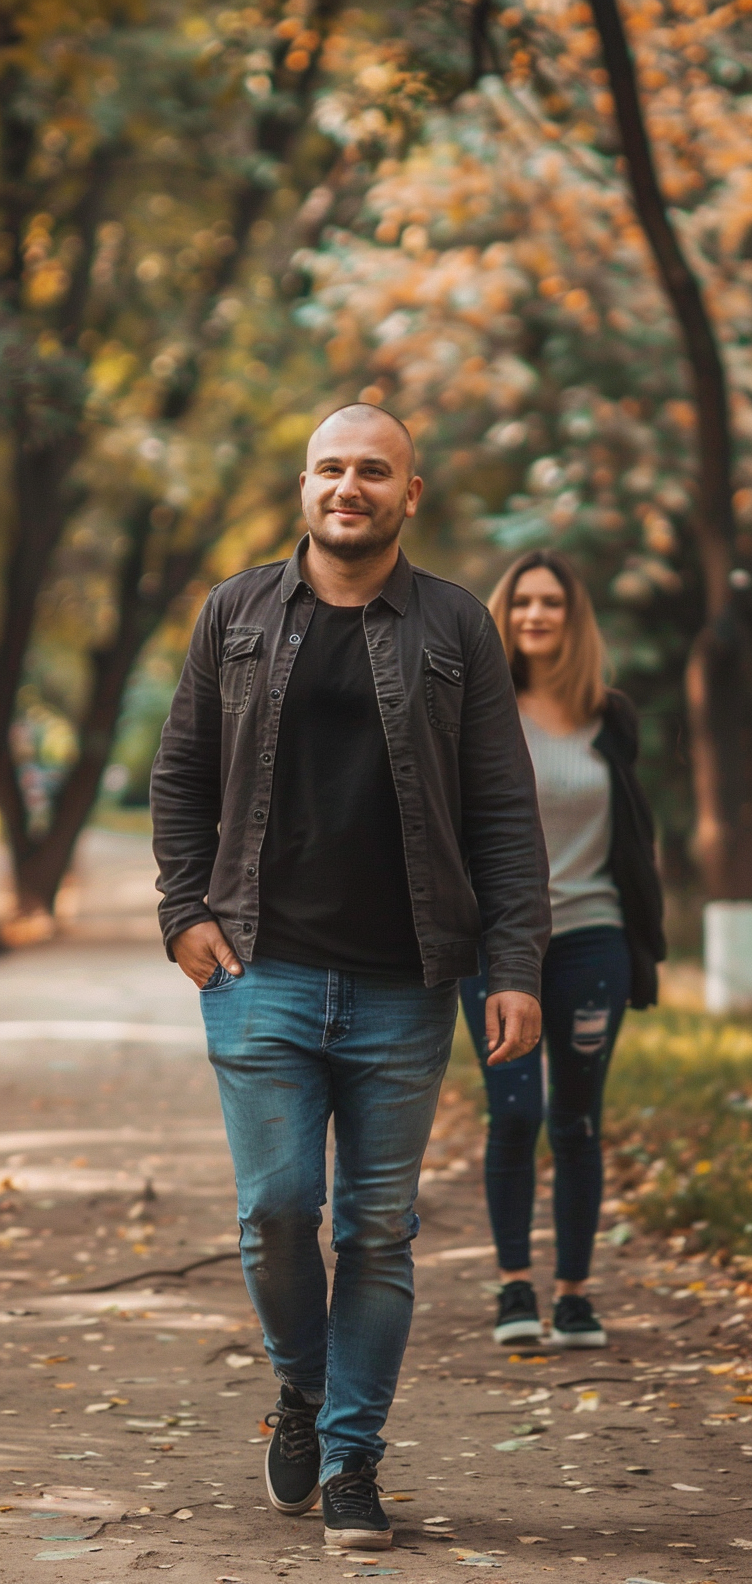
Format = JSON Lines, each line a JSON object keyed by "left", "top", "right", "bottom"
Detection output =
{"left": 462, "top": 551, "right": 665, "bottom": 1348}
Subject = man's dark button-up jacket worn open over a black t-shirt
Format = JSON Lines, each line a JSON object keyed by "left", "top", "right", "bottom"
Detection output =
{"left": 152, "top": 539, "right": 551, "bottom": 996}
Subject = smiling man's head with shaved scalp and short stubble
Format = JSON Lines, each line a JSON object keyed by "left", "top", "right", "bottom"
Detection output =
{"left": 301, "top": 413, "right": 423, "bottom": 561}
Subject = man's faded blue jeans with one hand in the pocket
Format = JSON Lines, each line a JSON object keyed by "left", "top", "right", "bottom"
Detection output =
{"left": 201, "top": 958, "right": 458, "bottom": 1481}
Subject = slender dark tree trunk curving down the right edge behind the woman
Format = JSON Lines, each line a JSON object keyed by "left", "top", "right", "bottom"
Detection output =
{"left": 591, "top": 0, "right": 752, "bottom": 900}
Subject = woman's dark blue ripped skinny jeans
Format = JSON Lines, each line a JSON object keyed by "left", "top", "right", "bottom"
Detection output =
{"left": 461, "top": 925, "right": 632, "bottom": 1281}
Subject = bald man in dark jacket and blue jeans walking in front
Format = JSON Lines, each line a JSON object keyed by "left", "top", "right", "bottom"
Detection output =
{"left": 152, "top": 402, "right": 549, "bottom": 1549}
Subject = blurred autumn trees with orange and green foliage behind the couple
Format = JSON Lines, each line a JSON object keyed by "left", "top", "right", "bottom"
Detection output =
{"left": 0, "top": 0, "right": 752, "bottom": 933}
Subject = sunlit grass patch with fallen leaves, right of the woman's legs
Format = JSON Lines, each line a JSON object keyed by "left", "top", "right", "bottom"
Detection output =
{"left": 603, "top": 1007, "right": 752, "bottom": 1256}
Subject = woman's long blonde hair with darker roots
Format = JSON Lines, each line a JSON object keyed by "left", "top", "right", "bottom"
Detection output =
{"left": 488, "top": 550, "right": 606, "bottom": 725}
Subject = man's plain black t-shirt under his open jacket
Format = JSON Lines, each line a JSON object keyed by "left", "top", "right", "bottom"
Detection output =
{"left": 255, "top": 600, "right": 421, "bottom": 977}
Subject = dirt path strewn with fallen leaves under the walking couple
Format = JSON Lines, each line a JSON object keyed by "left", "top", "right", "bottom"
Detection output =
{"left": 0, "top": 944, "right": 752, "bottom": 1584}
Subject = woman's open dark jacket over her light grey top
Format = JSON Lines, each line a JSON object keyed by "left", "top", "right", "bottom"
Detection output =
{"left": 592, "top": 687, "right": 667, "bottom": 1007}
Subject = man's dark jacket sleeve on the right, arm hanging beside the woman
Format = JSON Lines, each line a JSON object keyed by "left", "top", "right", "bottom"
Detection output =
{"left": 459, "top": 616, "right": 551, "bottom": 1000}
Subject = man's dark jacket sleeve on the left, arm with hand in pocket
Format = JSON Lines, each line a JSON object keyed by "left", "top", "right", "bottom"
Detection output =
{"left": 152, "top": 594, "right": 222, "bottom": 961}
